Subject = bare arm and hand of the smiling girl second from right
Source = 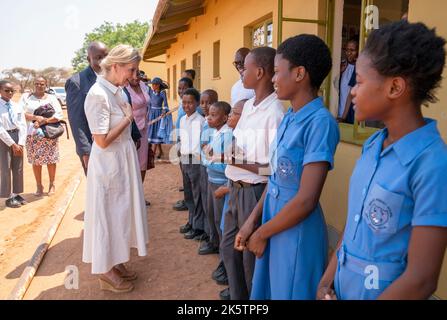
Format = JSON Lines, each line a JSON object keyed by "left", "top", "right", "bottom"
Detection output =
{"left": 248, "top": 162, "right": 329, "bottom": 258}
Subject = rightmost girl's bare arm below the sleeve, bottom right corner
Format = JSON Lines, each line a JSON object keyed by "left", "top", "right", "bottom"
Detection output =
{"left": 379, "top": 227, "right": 447, "bottom": 300}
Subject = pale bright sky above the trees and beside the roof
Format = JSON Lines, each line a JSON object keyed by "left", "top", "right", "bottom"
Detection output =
{"left": 0, "top": 0, "right": 158, "bottom": 72}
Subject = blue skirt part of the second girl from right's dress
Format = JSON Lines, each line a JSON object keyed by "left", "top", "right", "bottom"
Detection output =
{"left": 250, "top": 188, "right": 328, "bottom": 300}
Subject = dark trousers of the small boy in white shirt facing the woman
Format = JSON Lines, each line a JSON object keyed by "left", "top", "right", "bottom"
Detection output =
{"left": 182, "top": 161, "right": 205, "bottom": 230}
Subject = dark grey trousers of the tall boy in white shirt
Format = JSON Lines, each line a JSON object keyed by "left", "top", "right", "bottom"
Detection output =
{"left": 221, "top": 184, "right": 266, "bottom": 300}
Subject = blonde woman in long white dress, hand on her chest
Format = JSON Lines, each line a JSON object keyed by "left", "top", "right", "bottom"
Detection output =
{"left": 83, "top": 45, "right": 148, "bottom": 292}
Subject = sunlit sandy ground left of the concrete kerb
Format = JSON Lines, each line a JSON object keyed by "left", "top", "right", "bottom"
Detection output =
{"left": 0, "top": 107, "right": 82, "bottom": 299}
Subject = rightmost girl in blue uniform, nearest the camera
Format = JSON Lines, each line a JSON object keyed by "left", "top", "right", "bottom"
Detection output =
{"left": 318, "top": 21, "right": 447, "bottom": 300}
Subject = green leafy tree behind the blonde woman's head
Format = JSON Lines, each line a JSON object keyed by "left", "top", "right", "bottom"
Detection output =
{"left": 71, "top": 20, "right": 149, "bottom": 72}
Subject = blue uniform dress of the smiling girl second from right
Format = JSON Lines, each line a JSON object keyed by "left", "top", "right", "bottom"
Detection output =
{"left": 250, "top": 98, "right": 340, "bottom": 300}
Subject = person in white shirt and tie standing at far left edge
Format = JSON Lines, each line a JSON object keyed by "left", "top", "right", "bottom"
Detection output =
{"left": 0, "top": 81, "right": 26, "bottom": 208}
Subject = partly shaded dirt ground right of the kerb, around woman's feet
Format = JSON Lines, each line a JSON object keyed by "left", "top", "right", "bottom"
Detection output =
{"left": 25, "top": 164, "right": 224, "bottom": 300}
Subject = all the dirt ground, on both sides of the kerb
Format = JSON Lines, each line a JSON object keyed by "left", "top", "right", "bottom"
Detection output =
{"left": 0, "top": 95, "right": 225, "bottom": 300}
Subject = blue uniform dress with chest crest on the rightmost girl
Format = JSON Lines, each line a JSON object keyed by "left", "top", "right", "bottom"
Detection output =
{"left": 334, "top": 119, "right": 447, "bottom": 300}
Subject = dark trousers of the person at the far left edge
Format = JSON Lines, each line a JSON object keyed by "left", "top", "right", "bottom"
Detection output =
{"left": 0, "top": 131, "right": 23, "bottom": 198}
